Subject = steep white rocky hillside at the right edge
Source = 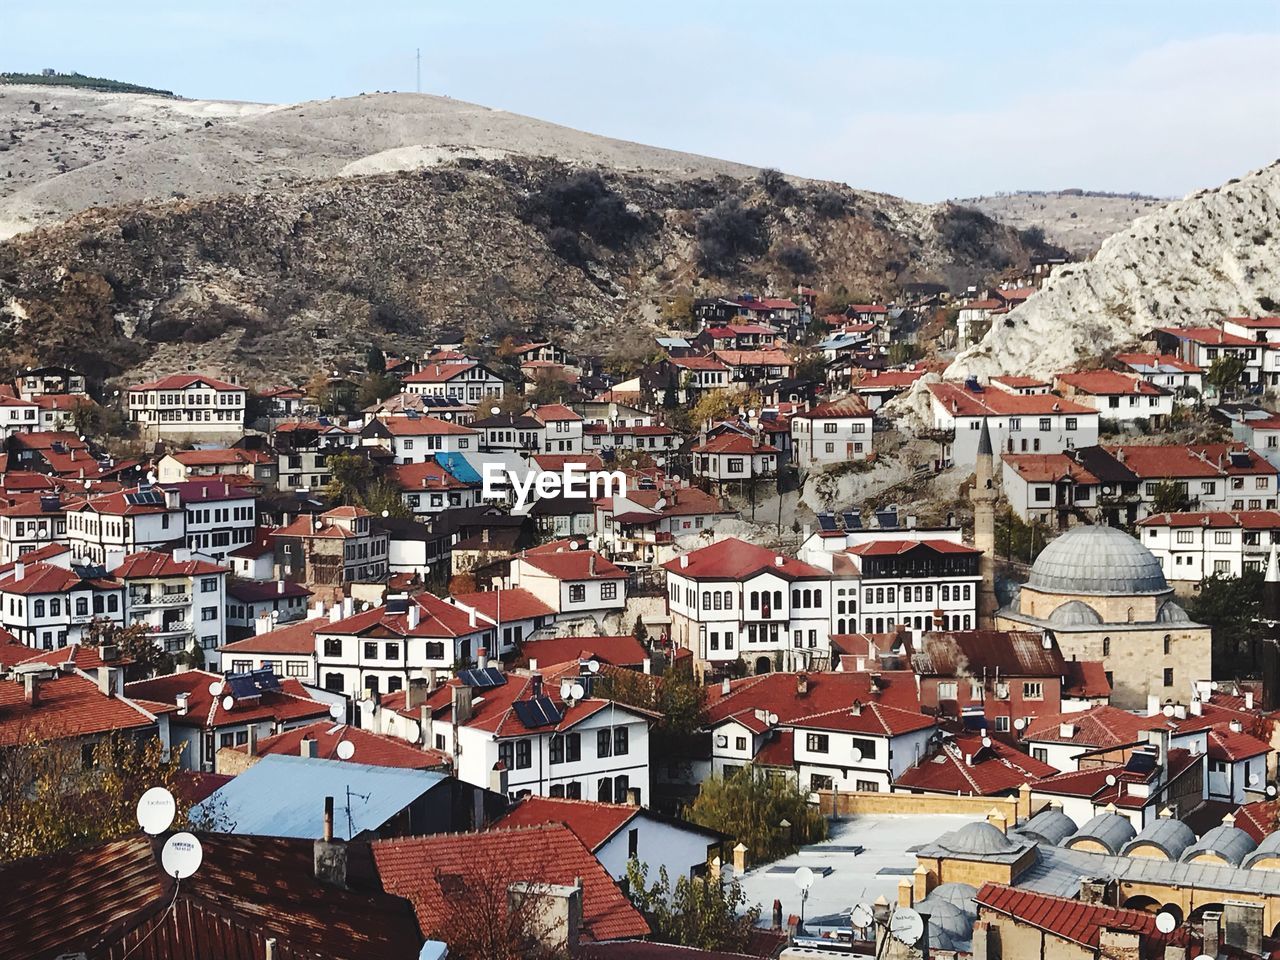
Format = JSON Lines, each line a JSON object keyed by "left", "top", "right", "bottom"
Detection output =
{"left": 947, "top": 163, "right": 1280, "bottom": 376}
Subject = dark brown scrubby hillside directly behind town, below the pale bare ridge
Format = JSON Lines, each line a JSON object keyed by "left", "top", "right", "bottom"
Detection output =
{"left": 0, "top": 156, "right": 1029, "bottom": 383}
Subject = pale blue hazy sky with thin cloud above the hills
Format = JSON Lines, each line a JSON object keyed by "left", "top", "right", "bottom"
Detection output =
{"left": 10, "top": 0, "right": 1280, "bottom": 200}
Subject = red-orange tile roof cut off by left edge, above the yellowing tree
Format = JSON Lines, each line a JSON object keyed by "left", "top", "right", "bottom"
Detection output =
{"left": 0, "top": 673, "right": 165, "bottom": 746}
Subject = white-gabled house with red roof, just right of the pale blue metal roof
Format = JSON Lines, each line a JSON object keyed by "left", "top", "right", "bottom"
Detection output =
{"left": 493, "top": 796, "right": 728, "bottom": 883}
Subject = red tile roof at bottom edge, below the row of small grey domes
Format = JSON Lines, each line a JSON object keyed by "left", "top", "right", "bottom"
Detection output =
{"left": 974, "top": 883, "right": 1187, "bottom": 955}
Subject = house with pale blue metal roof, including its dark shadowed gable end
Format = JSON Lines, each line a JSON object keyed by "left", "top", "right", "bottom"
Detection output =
{"left": 193, "top": 757, "right": 481, "bottom": 841}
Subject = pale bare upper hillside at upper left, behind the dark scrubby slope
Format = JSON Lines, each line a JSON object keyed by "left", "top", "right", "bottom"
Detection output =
{"left": 0, "top": 87, "right": 755, "bottom": 238}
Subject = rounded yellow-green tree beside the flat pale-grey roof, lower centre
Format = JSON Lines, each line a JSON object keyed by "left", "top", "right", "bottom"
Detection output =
{"left": 687, "top": 764, "right": 827, "bottom": 863}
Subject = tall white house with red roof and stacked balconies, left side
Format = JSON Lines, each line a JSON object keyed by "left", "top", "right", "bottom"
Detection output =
{"left": 111, "top": 550, "right": 227, "bottom": 667}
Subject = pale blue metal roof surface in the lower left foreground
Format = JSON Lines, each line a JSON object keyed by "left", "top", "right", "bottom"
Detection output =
{"left": 192, "top": 754, "right": 447, "bottom": 840}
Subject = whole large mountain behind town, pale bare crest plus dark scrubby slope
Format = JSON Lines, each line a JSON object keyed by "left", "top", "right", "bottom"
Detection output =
{"left": 0, "top": 88, "right": 1037, "bottom": 384}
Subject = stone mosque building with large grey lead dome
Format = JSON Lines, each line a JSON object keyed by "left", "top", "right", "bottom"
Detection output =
{"left": 995, "top": 526, "right": 1212, "bottom": 709}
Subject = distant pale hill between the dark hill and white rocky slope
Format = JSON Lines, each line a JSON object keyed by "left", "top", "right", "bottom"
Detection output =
{"left": 955, "top": 189, "right": 1167, "bottom": 259}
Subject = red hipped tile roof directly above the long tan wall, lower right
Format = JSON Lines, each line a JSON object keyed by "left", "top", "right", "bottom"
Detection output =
{"left": 893, "top": 736, "right": 1057, "bottom": 796}
